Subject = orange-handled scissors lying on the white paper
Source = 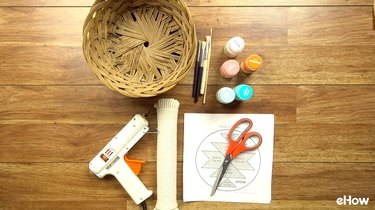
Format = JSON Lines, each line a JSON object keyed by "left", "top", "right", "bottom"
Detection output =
{"left": 211, "top": 118, "right": 262, "bottom": 196}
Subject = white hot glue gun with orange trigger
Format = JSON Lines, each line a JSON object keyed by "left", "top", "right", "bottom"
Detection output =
{"left": 89, "top": 114, "right": 152, "bottom": 206}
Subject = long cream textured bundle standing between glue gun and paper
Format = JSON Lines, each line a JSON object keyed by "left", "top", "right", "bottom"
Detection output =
{"left": 154, "top": 99, "right": 180, "bottom": 210}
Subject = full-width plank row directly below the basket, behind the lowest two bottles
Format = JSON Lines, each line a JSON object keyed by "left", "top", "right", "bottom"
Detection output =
{"left": 0, "top": 86, "right": 375, "bottom": 124}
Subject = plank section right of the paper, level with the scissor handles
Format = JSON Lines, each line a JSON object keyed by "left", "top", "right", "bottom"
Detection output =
{"left": 274, "top": 123, "right": 375, "bottom": 163}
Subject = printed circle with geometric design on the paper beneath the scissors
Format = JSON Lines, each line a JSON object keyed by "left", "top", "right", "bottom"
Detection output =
{"left": 195, "top": 129, "right": 261, "bottom": 191}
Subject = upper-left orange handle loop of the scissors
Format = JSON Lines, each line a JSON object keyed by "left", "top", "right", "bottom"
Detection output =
{"left": 225, "top": 118, "right": 253, "bottom": 155}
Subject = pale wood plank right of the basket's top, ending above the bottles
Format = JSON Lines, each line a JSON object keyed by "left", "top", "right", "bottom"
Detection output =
{"left": 194, "top": 7, "right": 288, "bottom": 46}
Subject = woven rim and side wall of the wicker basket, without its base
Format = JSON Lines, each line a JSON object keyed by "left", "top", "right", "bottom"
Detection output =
{"left": 82, "top": 0, "right": 197, "bottom": 97}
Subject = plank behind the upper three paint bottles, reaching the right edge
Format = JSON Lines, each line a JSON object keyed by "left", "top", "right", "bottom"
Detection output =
{"left": 201, "top": 45, "right": 375, "bottom": 85}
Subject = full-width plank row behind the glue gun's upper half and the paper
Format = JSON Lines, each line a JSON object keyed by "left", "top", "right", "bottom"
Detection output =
{"left": 0, "top": 123, "right": 375, "bottom": 163}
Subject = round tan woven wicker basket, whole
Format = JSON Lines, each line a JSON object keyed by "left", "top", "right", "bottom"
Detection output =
{"left": 83, "top": 0, "right": 197, "bottom": 97}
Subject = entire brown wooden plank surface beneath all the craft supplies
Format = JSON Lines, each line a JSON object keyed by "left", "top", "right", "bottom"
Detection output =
{"left": 0, "top": 0, "right": 375, "bottom": 210}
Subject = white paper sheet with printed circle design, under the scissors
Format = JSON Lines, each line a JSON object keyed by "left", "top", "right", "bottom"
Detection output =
{"left": 183, "top": 113, "right": 274, "bottom": 203}
